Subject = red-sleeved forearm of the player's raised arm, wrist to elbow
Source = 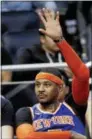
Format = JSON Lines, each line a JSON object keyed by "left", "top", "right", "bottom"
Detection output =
{"left": 57, "top": 40, "right": 89, "bottom": 81}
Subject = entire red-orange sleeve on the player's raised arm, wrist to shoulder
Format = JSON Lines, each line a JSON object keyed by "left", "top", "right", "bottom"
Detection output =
{"left": 57, "top": 40, "right": 89, "bottom": 105}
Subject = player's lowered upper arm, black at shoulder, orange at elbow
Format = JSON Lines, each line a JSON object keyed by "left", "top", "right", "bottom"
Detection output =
{"left": 15, "top": 108, "right": 33, "bottom": 139}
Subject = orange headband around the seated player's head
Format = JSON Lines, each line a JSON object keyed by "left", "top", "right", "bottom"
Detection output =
{"left": 35, "top": 72, "right": 63, "bottom": 85}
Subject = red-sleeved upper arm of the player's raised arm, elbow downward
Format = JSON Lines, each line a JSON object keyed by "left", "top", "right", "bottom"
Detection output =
{"left": 72, "top": 63, "right": 90, "bottom": 105}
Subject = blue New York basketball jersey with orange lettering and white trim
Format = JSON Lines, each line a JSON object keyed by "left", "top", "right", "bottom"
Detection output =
{"left": 31, "top": 102, "right": 85, "bottom": 135}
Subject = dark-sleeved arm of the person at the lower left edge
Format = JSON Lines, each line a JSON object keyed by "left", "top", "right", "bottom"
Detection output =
{"left": 0, "top": 96, "right": 14, "bottom": 139}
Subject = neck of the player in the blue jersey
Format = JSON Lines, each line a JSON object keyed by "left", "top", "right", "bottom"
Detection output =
{"left": 40, "top": 101, "right": 60, "bottom": 112}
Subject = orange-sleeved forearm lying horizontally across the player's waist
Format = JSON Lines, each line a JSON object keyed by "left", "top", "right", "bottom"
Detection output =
{"left": 16, "top": 124, "right": 71, "bottom": 139}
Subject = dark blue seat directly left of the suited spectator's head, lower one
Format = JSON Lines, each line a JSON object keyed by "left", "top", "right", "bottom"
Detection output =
{"left": 2, "top": 29, "right": 40, "bottom": 60}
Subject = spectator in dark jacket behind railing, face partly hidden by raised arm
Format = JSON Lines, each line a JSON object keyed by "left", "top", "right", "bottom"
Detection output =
{"left": 14, "top": 30, "right": 64, "bottom": 80}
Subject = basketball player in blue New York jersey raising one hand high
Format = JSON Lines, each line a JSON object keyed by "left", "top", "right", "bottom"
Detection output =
{"left": 16, "top": 9, "right": 89, "bottom": 139}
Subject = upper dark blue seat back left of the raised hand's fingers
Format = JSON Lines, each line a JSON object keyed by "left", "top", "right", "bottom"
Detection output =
{"left": 1, "top": 11, "right": 40, "bottom": 32}
